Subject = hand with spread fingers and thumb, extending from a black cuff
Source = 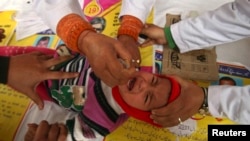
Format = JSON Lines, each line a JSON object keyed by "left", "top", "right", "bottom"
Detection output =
{"left": 7, "top": 52, "right": 78, "bottom": 109}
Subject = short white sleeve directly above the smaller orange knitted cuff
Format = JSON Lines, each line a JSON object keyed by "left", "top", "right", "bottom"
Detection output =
{"left": 119, "top": 0, "right": 156, "bottom": 23}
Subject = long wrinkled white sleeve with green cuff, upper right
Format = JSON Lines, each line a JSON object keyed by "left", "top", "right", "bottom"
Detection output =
{"left": 171, "top": 0, "right": 250, "bottom": 53}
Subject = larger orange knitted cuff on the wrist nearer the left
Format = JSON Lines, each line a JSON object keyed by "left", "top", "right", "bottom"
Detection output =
{"left": 56, "top": 14, "right": 95, "bottom": 52}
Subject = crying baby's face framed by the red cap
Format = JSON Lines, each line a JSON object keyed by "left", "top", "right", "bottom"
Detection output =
{"left": 119, "top": 71, "right": 171, "bottom": 111}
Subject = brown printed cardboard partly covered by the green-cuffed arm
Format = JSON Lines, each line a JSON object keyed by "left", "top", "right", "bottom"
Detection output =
{"left": 161, "top": 14, "right": 219, "bottom": 81}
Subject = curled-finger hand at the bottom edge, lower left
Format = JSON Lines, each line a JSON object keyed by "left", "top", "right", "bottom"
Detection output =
{"left": 24, "top": 120, "right": 68, "bottom": 141}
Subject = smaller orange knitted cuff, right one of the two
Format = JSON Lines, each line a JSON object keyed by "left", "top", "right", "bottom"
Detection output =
{"left": 118, "top": 15, "right": 143, "bottom": 41}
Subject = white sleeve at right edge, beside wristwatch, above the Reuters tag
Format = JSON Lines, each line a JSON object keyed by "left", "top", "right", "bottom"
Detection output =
{"left": 208, "top": 85, "right": 250, "bottom": 124}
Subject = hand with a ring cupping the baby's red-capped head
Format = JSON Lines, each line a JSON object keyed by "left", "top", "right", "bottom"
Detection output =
{"left": 151, "top": 76, "right": 204, "bottom": 127}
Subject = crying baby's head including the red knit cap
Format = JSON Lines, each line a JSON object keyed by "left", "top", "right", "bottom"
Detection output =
{"left": 112, "top": 71, "right": 180, "bottom": 126}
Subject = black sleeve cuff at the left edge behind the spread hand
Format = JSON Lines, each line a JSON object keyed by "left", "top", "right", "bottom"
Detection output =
{"left": 0, "top": 56, "right": 10, "bottom": 84}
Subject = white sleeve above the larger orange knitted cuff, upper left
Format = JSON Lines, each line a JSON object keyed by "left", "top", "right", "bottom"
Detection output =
{"left": 33, "top": 0, "right": 84, "bottom": 33}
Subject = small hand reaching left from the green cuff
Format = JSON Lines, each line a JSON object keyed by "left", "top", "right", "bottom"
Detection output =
{"left": 140, "top": 24, "right": 167, "bottom": 47}
